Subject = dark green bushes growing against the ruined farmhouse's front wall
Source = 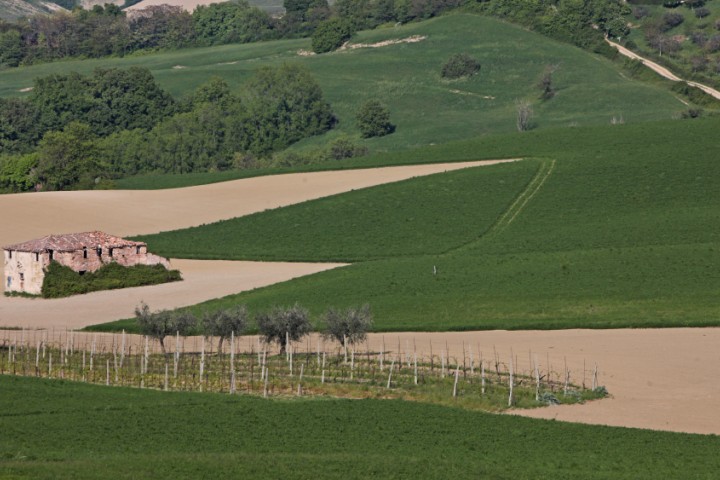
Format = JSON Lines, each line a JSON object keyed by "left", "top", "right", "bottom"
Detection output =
{"left": 42, "top": 262, "right": 182, "bottom": 298}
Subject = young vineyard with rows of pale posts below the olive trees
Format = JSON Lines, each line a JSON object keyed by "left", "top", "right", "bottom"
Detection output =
{"left": 0, "top": 330, "right": 607, "bottom": 410}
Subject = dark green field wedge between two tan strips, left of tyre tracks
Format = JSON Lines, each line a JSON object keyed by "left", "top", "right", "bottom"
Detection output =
{"left": 138, "top": 160, "right": 539, "bottom": 262}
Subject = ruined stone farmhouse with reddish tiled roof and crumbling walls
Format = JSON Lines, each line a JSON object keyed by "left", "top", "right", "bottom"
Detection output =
{"left": 3, "top": 232, "right": 170, "bottom": 295}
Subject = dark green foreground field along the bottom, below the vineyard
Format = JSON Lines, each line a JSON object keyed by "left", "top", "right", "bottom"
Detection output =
{"left": 0, "top": 377, "right": 720, "bottom": 479}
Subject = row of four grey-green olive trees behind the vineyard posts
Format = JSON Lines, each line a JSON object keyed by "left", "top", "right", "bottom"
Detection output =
{"left": 135, "top": 303, "right": 373, "bottom": 353}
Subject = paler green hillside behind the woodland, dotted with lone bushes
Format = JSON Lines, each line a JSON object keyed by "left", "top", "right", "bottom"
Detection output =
{"left": 0, "top": 15, "right": 686, "bottom": 158}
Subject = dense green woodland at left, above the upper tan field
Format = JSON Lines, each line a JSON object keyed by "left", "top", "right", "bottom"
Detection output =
{"left": 0, "top": 65, "right": 336, "bottom": 191}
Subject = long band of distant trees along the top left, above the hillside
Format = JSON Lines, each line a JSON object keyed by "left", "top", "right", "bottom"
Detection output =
{"left": 0, "top": 0, "right": 463, "bottom": 67}
